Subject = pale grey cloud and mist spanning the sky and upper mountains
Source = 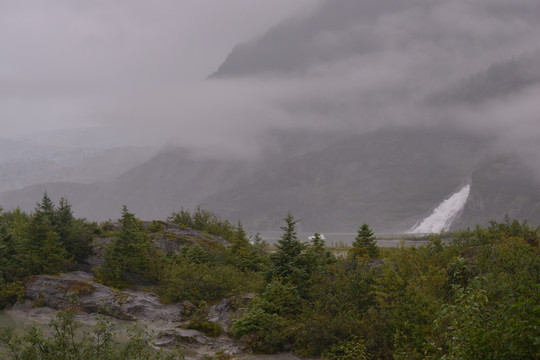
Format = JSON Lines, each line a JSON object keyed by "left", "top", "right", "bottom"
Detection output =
{"left": 0, "top": 0, "right": 540, "bottom": 165}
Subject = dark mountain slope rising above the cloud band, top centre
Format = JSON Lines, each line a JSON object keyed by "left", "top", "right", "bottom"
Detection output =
{"left": 211, "top": 0, "right": 418, "bottom": 78}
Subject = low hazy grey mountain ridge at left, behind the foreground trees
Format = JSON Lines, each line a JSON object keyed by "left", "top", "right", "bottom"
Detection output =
{"left": 0, "top": 149, "right": 248, "bottom": 221}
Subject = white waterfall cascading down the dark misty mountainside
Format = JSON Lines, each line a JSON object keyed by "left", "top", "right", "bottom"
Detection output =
{"left": 408, "top": 185, "right": 471, "bottom": 234}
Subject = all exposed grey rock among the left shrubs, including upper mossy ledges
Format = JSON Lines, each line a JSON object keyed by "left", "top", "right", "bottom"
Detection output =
{"left": 0, "top": 222, "right": 272, "bottom": 359}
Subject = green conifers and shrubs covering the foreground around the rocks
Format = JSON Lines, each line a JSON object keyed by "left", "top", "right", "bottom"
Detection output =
{"left": 0, "top": 197, "right": 540, "bottom": 359}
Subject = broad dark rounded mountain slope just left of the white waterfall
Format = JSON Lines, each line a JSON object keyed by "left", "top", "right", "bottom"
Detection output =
{"left": 204, "top": 128, "right": 486, "bottom": 231}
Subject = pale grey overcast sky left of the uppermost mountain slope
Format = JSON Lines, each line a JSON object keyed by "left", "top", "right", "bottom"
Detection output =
{"left": 0, "top": 0, "right": 315, "bottom": 140}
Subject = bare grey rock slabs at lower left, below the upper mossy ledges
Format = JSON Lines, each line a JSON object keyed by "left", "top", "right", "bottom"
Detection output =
{"left": 12, "top": 271, "right": 262, "bottom": 360}
